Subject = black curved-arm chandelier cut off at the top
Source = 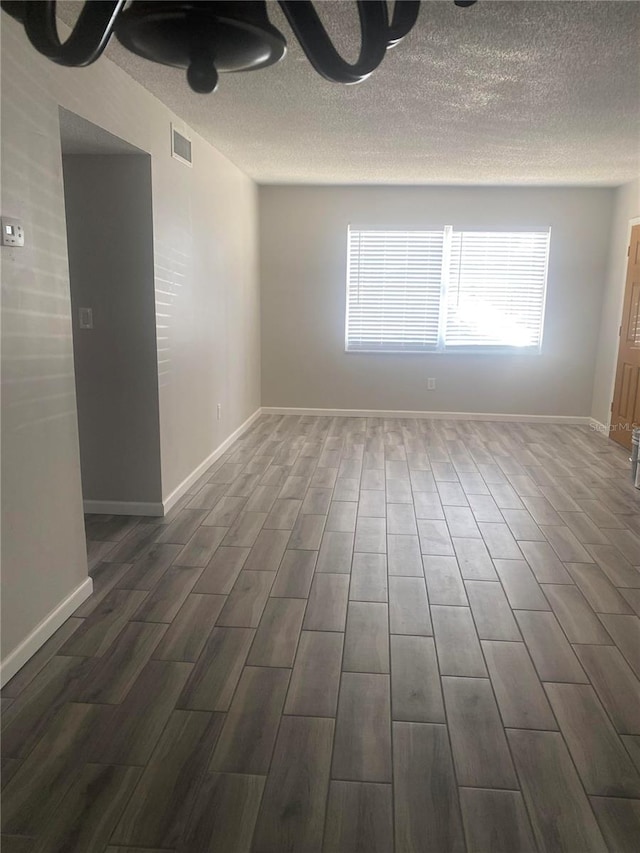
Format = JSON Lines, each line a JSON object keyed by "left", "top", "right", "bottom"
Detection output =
{"left": 0, "top": 0, "right": 476, "bottom": 93}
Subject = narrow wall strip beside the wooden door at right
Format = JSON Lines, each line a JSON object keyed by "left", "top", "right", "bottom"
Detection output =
{"left": 591, "top": 178, "right": 640, "bottom": 426}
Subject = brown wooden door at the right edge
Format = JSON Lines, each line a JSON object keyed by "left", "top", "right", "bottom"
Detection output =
{"left": 610, "top": 225, "right": 640, "bottom": 448}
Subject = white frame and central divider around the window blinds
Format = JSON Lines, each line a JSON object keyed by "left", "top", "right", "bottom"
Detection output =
{"left": 344, "top": 223, "right": 552, "bottom": 357}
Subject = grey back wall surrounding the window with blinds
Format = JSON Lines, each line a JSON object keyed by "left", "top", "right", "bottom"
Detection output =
{"left": 260, "top": 186, "right": 614, "bottom": 416}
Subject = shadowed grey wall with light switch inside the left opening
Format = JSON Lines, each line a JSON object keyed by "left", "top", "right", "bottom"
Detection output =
{"left": 62, "top": 149, "right": 162, "bottom": 504}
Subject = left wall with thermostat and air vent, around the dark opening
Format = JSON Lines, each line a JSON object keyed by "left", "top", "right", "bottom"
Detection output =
{"left": 2, "top": 14, "right": 260, "bottom": 680}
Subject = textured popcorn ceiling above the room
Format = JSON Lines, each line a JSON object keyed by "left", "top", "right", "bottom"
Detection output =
{"left": 60, "top": 0, "right": 640, "bottom": 186}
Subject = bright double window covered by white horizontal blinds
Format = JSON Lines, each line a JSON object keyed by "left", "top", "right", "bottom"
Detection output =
{"left": 346, "top": 226, "right": 550, "bottom": 352}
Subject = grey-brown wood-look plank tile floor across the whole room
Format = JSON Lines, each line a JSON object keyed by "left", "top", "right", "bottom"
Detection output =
{"left": 2, "top": 416, "right": 640, "bottom": 853}
